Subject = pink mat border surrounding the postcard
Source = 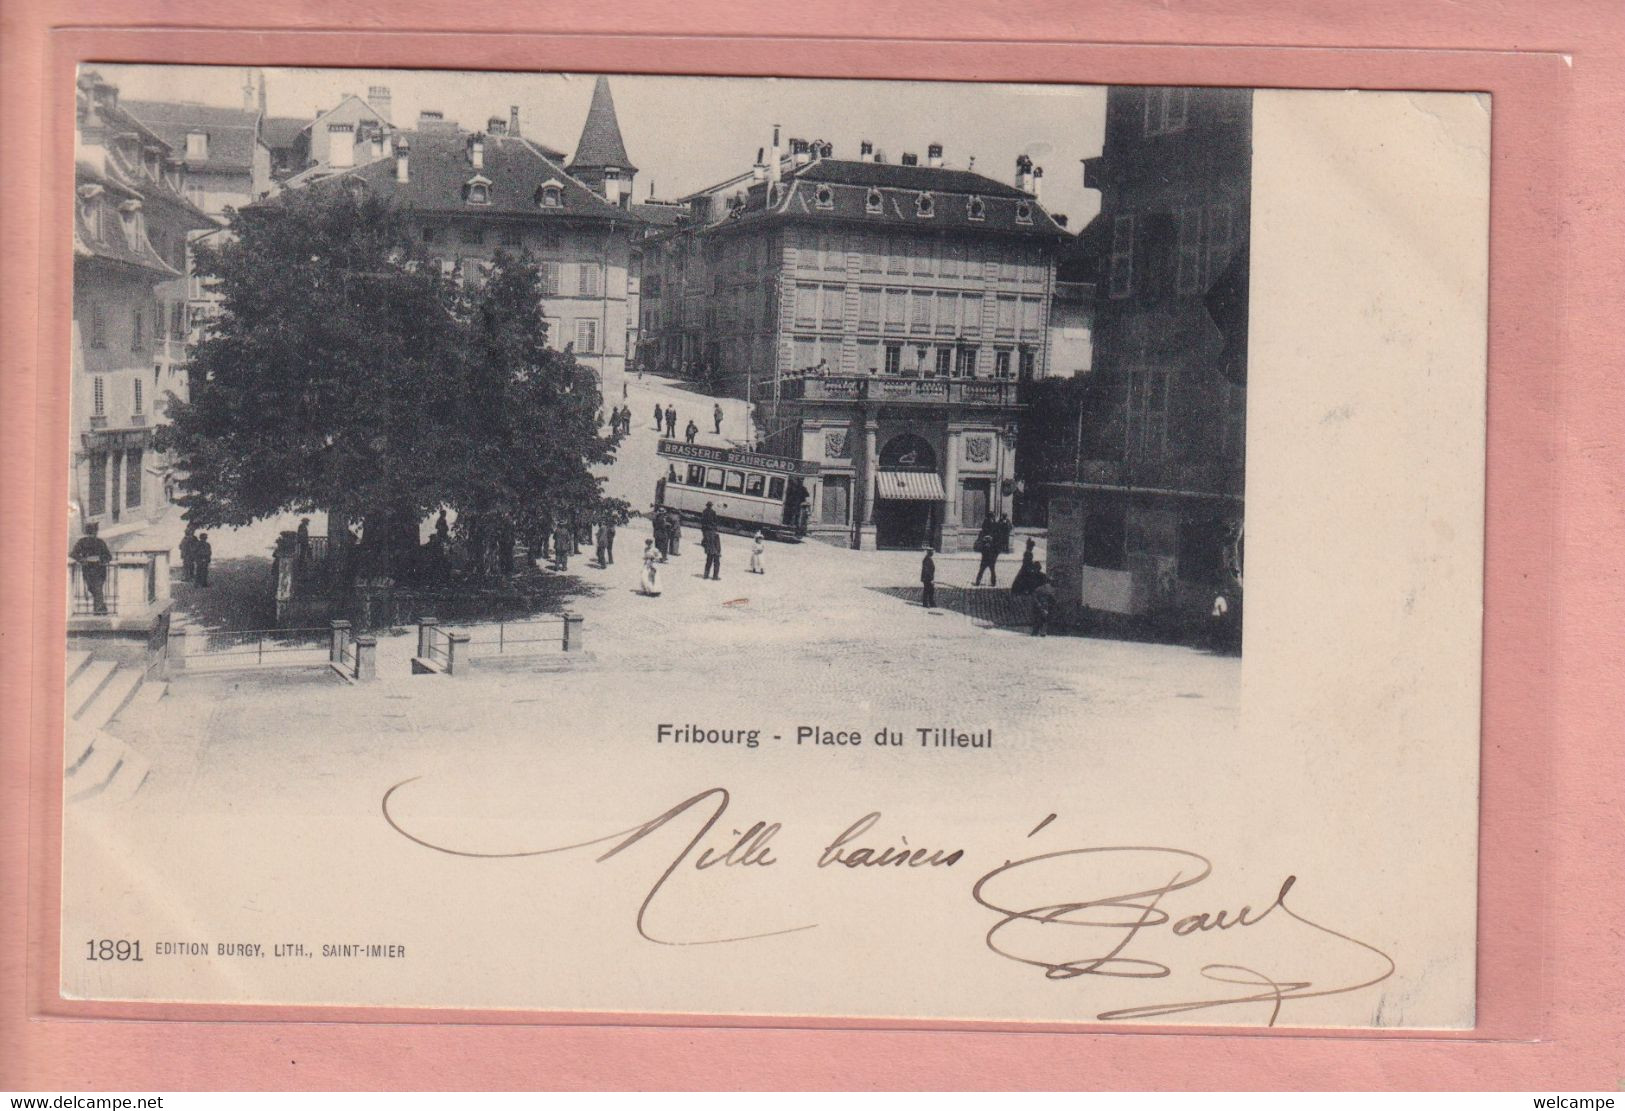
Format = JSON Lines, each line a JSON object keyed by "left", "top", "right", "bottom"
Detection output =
{"left": 0, "top": 0, "right": 1625, "bottom": 1090}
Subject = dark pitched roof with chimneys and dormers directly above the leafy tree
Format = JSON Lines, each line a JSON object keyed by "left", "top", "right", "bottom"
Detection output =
{"left": 322, "top": 132, "right": 637, "bottom": 223}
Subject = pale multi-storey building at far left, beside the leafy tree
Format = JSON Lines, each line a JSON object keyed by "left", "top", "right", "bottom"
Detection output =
{"left": 72, "top": 73, "right": 215, "bottom": 538}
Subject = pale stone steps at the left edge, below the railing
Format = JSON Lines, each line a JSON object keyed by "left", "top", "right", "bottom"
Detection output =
{"left": 65, "top": 651, "right": 150, "bottom": 802}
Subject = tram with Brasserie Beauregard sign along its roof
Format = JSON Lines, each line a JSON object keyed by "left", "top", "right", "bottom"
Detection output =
{"left": 655, "top": 440, "right": 819, "bottom": 539}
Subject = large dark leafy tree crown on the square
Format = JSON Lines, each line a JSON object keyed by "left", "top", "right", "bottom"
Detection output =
{"left": 159, "top": 187, "right": 614, "bottom": 568}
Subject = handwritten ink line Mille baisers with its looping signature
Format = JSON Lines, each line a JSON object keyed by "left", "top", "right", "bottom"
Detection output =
{"left": 380, "top": 776, "right": 1396, "bottom": 1027}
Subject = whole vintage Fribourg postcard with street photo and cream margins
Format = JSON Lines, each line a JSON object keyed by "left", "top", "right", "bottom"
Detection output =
{"left": 60, "top": 62, "right": 1490, "bottom": 1028}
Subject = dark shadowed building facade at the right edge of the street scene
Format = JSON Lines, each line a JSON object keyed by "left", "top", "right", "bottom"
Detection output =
{"left": 1047, "top": 88, "right": 1251, "bottom": 627}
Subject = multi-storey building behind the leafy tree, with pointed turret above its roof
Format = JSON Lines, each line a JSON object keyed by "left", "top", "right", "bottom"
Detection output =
{"left": 289, "top": 78, "right": 642, "bottom": 372}
